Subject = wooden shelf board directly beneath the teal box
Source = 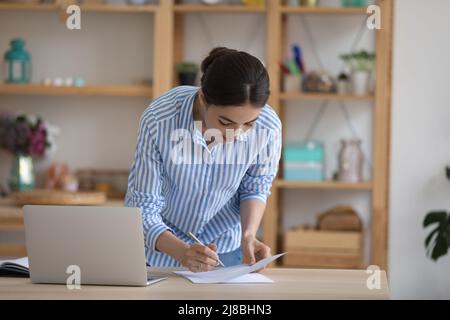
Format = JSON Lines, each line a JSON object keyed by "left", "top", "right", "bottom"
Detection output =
{"left": 273, "top": 180, "right": 372, "bottom": 190}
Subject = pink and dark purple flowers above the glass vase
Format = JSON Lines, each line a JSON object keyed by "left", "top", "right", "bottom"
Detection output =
{"left": 0, "top": 114, "right": 58, "bottom": 156}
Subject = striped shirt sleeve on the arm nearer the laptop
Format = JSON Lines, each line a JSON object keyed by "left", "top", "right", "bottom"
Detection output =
{"left": 125, "top": 110, "right": 173, "bottom": 251}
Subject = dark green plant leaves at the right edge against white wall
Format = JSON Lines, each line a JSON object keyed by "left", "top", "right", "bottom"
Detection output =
{"left": 423, "top": 167, "right": 450, "bottom": 261}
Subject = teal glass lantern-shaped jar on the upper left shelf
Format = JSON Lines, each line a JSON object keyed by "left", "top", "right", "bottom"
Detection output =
{"left": 4, "top": 38, "right": 31, "bottom": 83}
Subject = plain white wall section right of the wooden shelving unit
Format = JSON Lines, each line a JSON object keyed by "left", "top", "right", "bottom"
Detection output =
{"left": 389, "top": 0, "right": 450, "bottom": 299}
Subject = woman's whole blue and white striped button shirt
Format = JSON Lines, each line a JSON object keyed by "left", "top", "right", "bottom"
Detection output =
{"left": 125, "top": 86, "right": 281, "bottom": 267}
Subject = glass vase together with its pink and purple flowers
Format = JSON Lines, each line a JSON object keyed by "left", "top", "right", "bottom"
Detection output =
{"left": 0, "top": 114, "right": 58, "bottom": 191}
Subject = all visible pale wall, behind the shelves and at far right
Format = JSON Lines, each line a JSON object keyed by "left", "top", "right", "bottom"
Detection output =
{"left": 0, "top": 0, "right": 450, "bottom": 298}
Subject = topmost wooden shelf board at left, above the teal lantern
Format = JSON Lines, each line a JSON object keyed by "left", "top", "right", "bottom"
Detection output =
{"left": 0, "top": 3, "right": 158, "bottom": 13}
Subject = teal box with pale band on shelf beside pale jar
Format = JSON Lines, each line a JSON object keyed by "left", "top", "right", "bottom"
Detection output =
{"left": 283, "top": 141, "right": 325, "bottom": 181}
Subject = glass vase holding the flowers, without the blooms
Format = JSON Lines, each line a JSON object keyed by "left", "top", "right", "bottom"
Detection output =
{"left": 9, "top": 153, "right": 36, "bottom": 192}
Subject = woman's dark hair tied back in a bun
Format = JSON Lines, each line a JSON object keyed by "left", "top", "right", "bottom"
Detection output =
{"left": 201, "top": 47, "right": 270, "bottom": 107}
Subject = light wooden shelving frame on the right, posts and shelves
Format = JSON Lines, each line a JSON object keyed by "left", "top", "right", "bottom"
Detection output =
{"left": 264, "top": 0, "right": 393, "bottom": 269}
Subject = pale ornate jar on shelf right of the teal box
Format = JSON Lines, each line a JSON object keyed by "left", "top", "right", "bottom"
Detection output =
{"left": 338, "top": 139, "right": 364, "bottom": 182}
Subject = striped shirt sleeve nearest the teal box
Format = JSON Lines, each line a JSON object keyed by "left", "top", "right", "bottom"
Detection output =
{"left": 239, "top": 126, "right": 282, "bottom": 203}
